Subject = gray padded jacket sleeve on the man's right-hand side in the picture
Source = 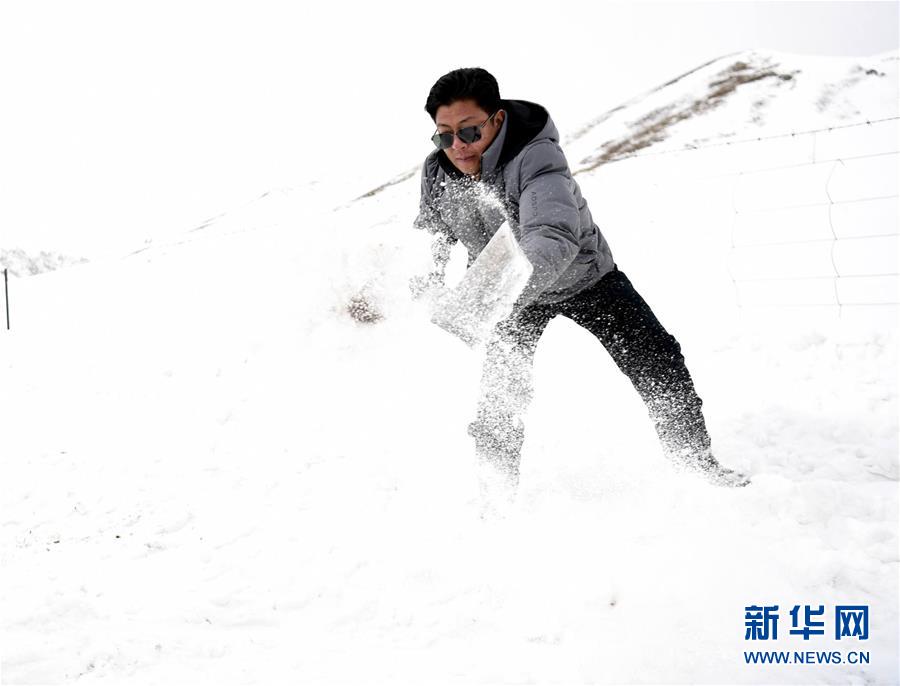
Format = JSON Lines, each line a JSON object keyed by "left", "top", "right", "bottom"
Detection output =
{"left": 516, "top": 140, "right": 581, "bottom": 309}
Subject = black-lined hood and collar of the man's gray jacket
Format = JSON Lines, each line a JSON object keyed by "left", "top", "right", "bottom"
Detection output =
{"left": 437, "top": 100, "right": 559, "bottom": 178}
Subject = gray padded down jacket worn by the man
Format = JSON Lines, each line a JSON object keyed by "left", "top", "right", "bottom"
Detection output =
{"left": 414, "top": 100, "right": 613, "bottom": 307}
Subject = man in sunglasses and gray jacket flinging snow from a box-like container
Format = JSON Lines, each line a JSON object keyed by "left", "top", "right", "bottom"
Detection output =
{"left": 411, "top": 68, "right": 749, "bottom": 489}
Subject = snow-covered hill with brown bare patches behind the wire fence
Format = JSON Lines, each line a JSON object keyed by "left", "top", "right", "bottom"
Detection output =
{"left": 566, "top": 51, "right": 898, "bottom": 173}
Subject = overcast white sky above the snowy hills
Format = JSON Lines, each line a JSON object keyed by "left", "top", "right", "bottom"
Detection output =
{"left": 0, "top": 0, "right": 900, "bottom": 256}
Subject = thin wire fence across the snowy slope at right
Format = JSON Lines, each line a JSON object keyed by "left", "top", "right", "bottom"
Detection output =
{"left": 576, "top": 116, "right": 900, "bottom": 316}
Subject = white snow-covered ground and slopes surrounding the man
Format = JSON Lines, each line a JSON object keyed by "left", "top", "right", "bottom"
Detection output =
{"left": 0, "top": 49, "right": 900, "bottom": 684}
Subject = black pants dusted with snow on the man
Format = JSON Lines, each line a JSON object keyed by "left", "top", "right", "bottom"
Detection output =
{"left": 469, "top": 267, "right": 710, "bottom": 481}
